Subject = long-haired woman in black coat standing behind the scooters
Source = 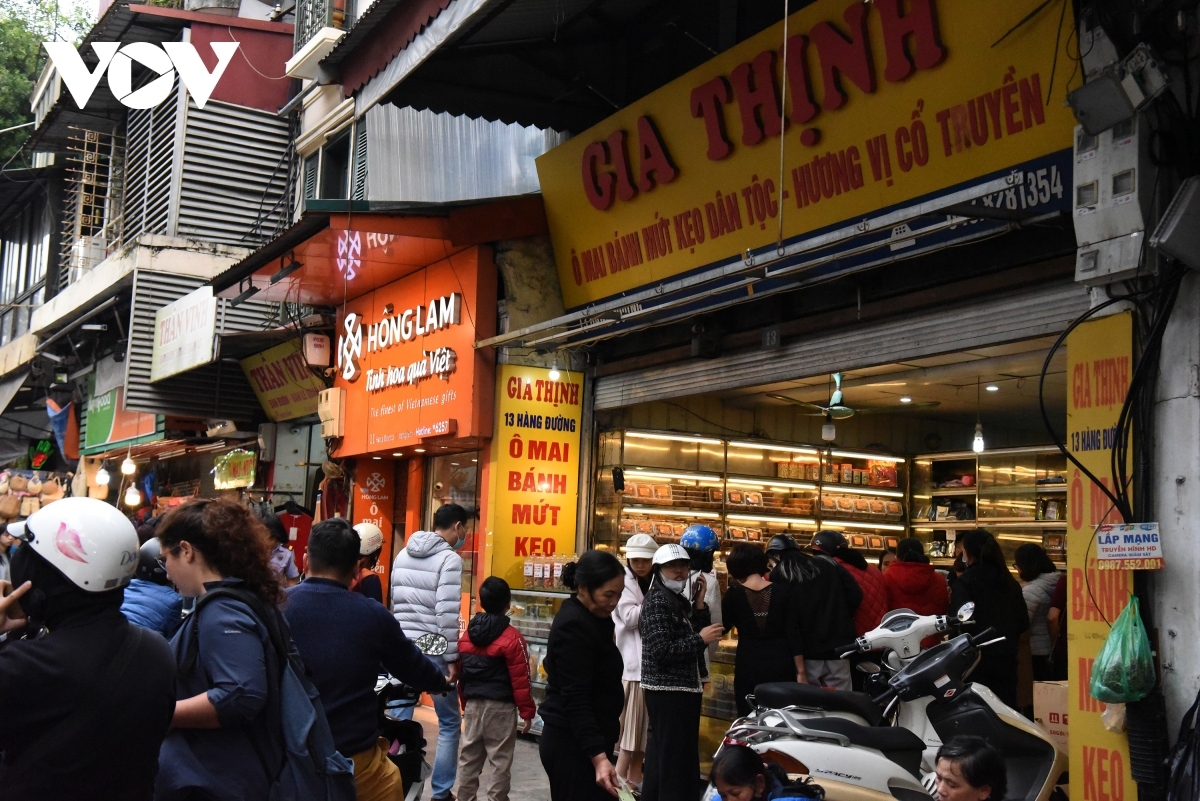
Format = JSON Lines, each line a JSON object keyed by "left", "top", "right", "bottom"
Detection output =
{"left": 949, "top": 529, "right": 1030, "bottom": 709}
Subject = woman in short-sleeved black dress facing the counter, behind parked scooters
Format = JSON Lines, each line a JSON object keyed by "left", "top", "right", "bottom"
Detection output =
{"left": 721, "top": 543, "right": 808, "bottom": 716}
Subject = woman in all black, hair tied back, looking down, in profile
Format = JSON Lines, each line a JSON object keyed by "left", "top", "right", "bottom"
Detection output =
{"left": 538, "top": 550, "right": 625, "bottom": 801}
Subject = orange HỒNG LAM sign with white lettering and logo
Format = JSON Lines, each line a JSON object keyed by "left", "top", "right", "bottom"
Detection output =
{"left": 335, "top": 247, "right": 496, "bottom": 456}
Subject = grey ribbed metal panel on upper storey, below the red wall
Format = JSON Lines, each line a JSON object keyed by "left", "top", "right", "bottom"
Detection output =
{"left": 175, "top": 98, "right": 289, "bottom": 247}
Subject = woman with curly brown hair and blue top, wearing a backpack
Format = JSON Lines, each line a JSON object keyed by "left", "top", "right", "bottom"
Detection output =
{"left": 155, "top": 500, "right": 283, "bottom": 801}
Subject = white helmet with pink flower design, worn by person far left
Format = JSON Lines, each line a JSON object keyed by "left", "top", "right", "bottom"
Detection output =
{"left": 8, "top": 498, "right": 138, "bottom": 592}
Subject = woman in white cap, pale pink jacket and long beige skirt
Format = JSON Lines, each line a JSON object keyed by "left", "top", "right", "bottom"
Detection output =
{"left": 612, "top": 534, "right": 659, "bottom": 791}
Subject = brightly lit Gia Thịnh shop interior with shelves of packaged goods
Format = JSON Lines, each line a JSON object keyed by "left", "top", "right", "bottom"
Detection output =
{"left": 592, "top": 337, "right": 1080, "bottom": 767}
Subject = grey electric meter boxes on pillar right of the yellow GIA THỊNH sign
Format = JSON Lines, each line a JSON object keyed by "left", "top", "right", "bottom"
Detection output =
{"left": 1074, "top": 115, "right": 1154, "bottom": 285}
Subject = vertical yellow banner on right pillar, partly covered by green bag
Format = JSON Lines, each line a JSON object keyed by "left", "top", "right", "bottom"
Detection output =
{"left": 1067, "top": 312, "right": 1138, "bottom": 801}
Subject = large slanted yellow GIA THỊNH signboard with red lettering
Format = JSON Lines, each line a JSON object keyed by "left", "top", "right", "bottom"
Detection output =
{"left": 538, "top": 0, "right": 1075, "bottom": 308}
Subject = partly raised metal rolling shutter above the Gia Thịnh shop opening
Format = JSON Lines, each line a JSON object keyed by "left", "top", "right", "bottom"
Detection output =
{"left": 595, "top": 283, "right": 1088, "bottom": 410}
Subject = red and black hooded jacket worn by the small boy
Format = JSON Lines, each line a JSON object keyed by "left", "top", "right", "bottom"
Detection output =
{"left": 458, "top": 612, "right": 538, "bottom": 721}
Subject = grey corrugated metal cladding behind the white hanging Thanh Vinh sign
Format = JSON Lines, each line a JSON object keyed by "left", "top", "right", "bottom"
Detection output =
{"left": 125, "top": 270, "right": 276, "bottom": 421}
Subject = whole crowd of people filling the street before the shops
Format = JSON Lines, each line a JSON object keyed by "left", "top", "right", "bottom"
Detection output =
{"left": 0, "top": 491, "right": 1066, "bottom": 801}
